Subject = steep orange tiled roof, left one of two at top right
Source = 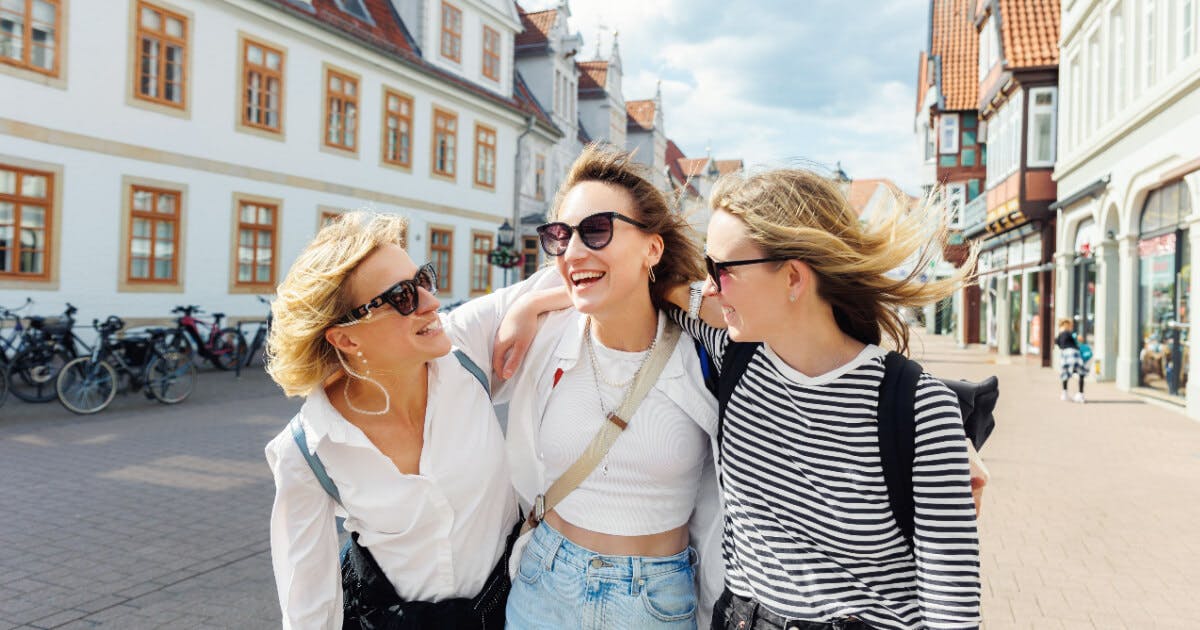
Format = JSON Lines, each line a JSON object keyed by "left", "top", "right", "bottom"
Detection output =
{"left": 918, "top": 0, "right": 979, "bottom": 112}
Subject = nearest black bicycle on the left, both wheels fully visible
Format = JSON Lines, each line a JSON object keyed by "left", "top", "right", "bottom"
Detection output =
{"left": 54, "top": 316, "right": 196, "bottom": 415}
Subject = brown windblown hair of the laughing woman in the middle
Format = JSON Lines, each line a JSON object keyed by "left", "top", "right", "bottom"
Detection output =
{"left": 551, "top": 143, "right": 704, "bottom": 308}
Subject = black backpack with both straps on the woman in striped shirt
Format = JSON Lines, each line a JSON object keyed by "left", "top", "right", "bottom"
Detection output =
{"left": 701, "top": 341, "right": 1000, "bottom": 544}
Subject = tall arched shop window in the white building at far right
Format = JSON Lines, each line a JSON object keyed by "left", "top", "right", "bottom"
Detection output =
{"left": 1138, "top": 181, "right": 1192, "bottom": 396}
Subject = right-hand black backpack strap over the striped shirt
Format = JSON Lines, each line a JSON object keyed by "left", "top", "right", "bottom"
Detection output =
{"left": 878, "top": 352, "right": 923, "bottom": 545}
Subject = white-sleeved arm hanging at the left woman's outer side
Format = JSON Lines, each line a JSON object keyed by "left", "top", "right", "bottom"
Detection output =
{"left": 266, "top": 432, "right": 342, "bottom": 630}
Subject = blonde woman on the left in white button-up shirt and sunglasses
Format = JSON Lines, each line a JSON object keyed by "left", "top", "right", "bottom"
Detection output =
{"left": 266, "top": 212, "right": 554, "bottom": 629}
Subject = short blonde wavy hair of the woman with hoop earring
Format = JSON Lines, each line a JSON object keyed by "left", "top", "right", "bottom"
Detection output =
{"left": 266, "top": 211, "right": 408, "bottom": 396}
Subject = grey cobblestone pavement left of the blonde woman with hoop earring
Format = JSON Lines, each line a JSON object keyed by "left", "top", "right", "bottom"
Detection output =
{"left": 0, "top": 368, "right": 290, "bottom": 630}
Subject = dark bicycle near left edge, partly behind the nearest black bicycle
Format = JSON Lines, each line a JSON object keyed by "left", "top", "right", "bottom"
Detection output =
{"left": 7, "top": 300, "right": 84, "bottom": 402}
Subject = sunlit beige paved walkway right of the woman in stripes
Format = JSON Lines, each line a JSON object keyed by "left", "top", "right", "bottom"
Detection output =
{"left": 912, "top": 336, "right": 1200, "bottom": 630}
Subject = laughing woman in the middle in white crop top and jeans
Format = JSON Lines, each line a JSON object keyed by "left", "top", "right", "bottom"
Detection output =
{"left": 446, "top": 146, "right": 722, "bottom": 629}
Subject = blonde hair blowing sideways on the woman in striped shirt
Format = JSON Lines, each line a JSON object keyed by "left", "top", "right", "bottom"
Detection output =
{"left": 710, "top": 168, "right": 978, "bottom": 354}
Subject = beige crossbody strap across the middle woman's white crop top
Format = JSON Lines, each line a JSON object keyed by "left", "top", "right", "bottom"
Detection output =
{"left": 521, "top": 319, "right": 682, "bottom": 533}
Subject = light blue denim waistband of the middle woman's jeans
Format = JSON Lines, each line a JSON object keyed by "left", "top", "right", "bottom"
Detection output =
{"left": 529, "top": 521, "right": 696, "bottom": 582}
